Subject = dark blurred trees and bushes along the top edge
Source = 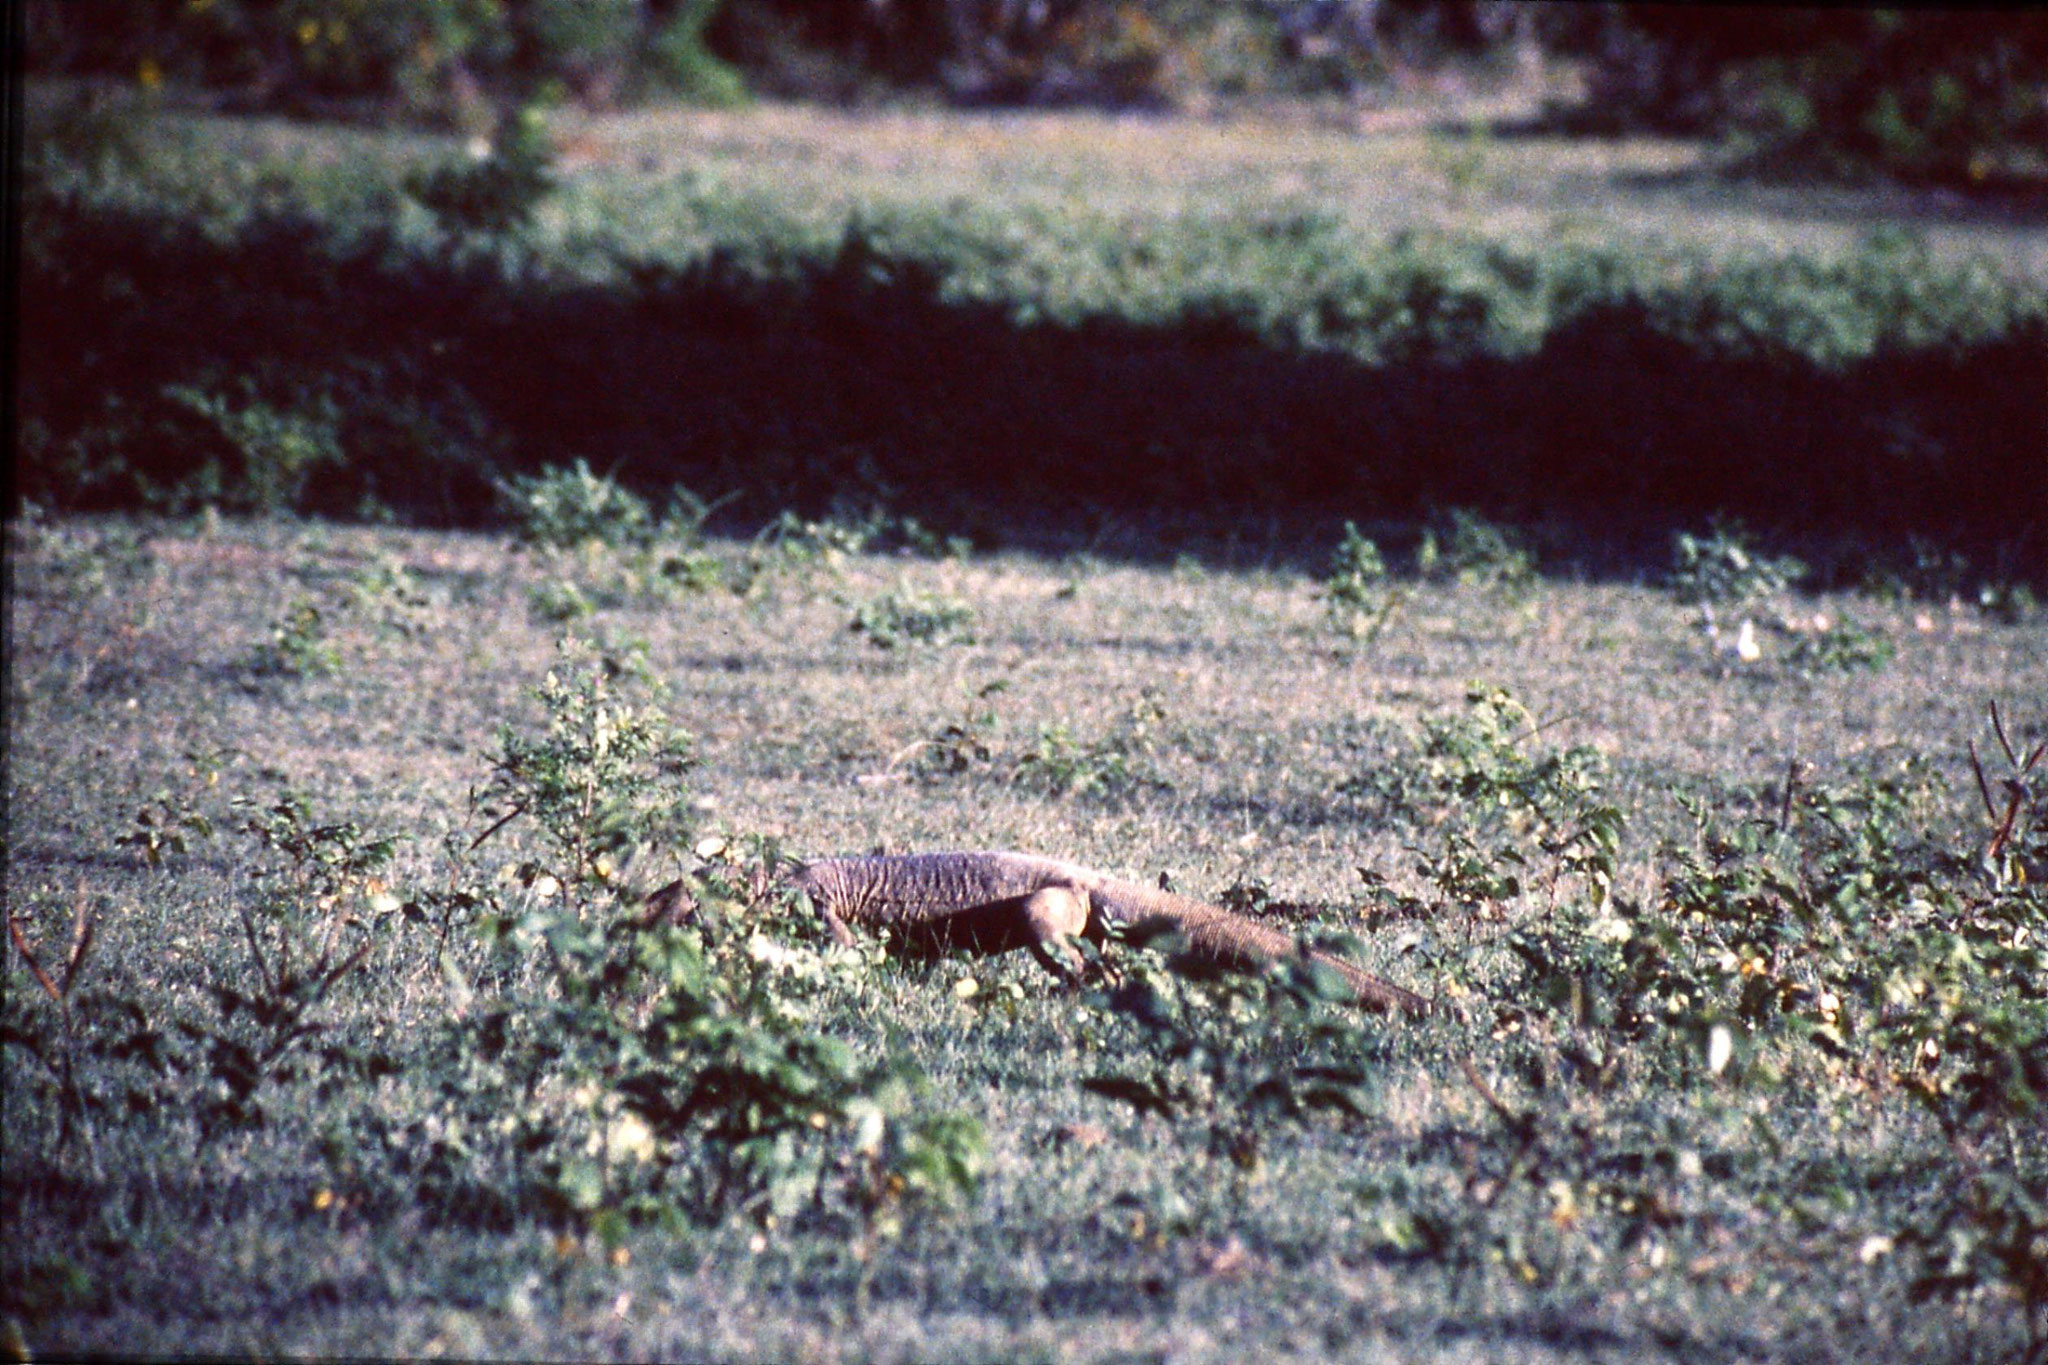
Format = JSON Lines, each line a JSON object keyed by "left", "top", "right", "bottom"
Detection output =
{"left": 27, "top": 0, "right": 2048, "bottom": 188}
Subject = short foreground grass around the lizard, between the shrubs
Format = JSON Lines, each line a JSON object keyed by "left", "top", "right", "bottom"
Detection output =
{"left": 0, "top": 520, "right": 2048, "bottom": 1361}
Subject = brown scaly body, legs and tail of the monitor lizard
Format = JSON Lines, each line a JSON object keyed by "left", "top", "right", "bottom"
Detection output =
{"left": 791, "top": 851, "right": 1430, "bottom": 1015}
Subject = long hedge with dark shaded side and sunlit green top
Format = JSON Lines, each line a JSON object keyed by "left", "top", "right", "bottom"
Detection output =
{"left": 18, "top": 174, "right": 2048, "bottom": 567}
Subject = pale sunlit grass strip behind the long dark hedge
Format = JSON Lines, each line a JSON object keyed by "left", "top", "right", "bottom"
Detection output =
{"left": 44, "top": 86, "right": 2048, "bottom": 280}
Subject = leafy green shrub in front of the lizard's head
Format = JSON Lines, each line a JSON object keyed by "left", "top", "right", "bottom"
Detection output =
{"left": 389, "top": 651, "right": 985, "bottom": 1244}
